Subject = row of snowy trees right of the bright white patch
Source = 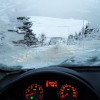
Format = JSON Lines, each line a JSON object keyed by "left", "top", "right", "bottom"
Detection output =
{"left": 67, "top": 24, "right": 100, "bottom": 45}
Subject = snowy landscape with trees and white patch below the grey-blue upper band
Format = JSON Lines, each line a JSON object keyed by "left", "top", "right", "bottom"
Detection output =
{"left": 0, "top": 16, "right": 100, "bottom": 70}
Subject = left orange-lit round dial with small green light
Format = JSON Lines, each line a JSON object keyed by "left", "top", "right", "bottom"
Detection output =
{"left": 25, "top": 84, "right": 43, "bottom": 100}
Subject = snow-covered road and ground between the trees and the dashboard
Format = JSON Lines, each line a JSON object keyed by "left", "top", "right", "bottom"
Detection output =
{"left": 0, "top": 41, "right": 100, "bottom": 69}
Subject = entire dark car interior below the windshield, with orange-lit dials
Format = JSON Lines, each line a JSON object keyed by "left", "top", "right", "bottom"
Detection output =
{"left": 0, "top": 65, "right": 100, "bottom": 100}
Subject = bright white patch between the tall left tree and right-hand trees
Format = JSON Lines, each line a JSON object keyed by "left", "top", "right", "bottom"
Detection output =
{"left": 30, "top": 16, "right": 88, "bottom": 38}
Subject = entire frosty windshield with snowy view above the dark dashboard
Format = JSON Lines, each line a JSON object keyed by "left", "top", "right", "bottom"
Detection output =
{"left": 0, "top": 0, "right": 100, "bottom": 70}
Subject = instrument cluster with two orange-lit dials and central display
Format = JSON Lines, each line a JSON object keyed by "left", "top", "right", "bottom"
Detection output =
{"left": 24, "top": 80, "right": 78, "bottom": 100}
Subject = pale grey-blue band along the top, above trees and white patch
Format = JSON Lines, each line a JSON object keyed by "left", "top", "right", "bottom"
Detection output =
{"left": 0, "top": 0, "right": 100, "bottom": 26}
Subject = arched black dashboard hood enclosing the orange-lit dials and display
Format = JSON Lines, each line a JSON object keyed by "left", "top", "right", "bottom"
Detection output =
{"left": 0, "top": 67, "right": 99, "bottom": 100}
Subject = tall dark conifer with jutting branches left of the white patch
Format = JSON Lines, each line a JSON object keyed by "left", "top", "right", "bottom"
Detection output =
{"left": 8, "top": 17, "right": 38, "bottom": 46}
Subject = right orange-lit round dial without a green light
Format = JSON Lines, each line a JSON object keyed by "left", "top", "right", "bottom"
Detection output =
{"left": 59, "top": 84, "right": 78, "bottom": 100}
